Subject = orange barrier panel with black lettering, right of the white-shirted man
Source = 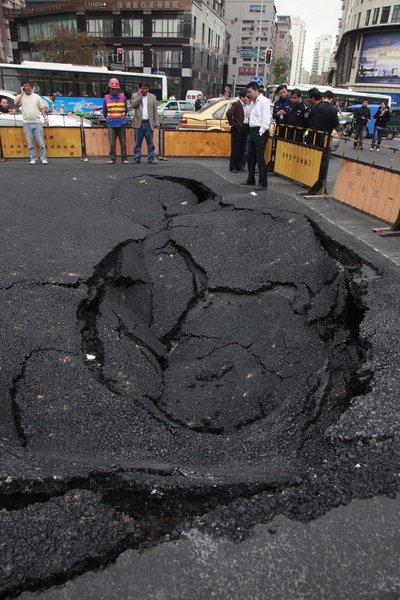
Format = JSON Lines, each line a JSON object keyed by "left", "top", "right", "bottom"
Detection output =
{"left": 274, "top": 138, "right": 323, "bottom": 186}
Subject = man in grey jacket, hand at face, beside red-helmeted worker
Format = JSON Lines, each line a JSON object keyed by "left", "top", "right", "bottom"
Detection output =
{"left": 131, "top": 81, "right": 160, "bottom": 164}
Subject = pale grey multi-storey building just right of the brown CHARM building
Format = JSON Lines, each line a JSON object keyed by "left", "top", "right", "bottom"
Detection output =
{"left": 225, "top": 0, "right": 276, "bottom": 88}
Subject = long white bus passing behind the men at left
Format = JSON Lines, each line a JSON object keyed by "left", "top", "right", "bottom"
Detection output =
{"left": 0, "top": 61, "right": 168, "bottom": 100}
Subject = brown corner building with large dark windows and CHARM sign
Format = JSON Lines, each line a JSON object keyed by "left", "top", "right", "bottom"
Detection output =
{"left": 7, "top": 0, "right": 226, "bottom": 97}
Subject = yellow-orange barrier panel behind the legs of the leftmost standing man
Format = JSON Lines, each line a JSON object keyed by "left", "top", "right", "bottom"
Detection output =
{"left": 0, "top": 127, "right": 82, "bottom": 158}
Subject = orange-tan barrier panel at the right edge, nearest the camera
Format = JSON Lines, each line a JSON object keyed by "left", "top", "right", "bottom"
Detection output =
{"left": 333, "top": 159, "right": 400, "bottom": 224}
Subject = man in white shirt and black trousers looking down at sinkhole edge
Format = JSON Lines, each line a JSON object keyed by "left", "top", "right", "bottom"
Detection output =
{"left": 239, "top": 81, "right": 271, "bottom": 189}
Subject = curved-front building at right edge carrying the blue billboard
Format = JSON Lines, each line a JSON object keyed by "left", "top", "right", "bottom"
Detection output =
{"left": 334, "top": 0, "right": 400, "bottom": 106}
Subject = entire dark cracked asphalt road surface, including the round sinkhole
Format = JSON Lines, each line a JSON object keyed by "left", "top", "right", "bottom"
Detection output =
{"left": 0, "top": 161, "right": 400, "bottom": 600}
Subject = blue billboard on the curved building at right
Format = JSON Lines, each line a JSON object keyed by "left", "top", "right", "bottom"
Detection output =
{"left": 356, "top": 31, "right": 400, "bottom": 83}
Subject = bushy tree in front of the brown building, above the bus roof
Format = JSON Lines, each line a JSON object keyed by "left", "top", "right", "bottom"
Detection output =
{"left": 32, "top": 27, "right": 105, "bottom": 65}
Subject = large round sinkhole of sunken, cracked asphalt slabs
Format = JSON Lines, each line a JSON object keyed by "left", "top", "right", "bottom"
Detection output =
{"left": 69, "top": 176, "right": 372, "bottom": 476}
